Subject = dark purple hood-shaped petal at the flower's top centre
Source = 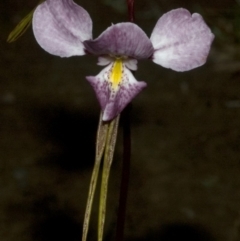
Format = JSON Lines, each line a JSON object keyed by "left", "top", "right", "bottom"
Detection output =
{"left": 84, "top": 23, "right": 153, "bottom": 59}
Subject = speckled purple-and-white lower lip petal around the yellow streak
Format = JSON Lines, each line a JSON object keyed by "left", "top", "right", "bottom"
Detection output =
{"left": 86, "top": 64, "right": 147, "bottom": 121}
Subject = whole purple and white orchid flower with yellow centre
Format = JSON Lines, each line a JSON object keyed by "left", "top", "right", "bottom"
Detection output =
{"left": 33, "top": 0, "right": 214, "bottom": 121}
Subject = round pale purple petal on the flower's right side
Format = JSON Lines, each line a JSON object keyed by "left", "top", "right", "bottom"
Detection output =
{"left": 150, "top": 8, "right": 214, "bottom": 71}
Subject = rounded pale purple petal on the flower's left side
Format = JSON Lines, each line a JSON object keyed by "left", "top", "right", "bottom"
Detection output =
{"left": 33, "top": 0, "right": 92, "bottom": 57}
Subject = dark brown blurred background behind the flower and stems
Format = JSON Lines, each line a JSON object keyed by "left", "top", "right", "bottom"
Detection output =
{"left": 0, "top": 0, "right": 240, "bottom": 241}
